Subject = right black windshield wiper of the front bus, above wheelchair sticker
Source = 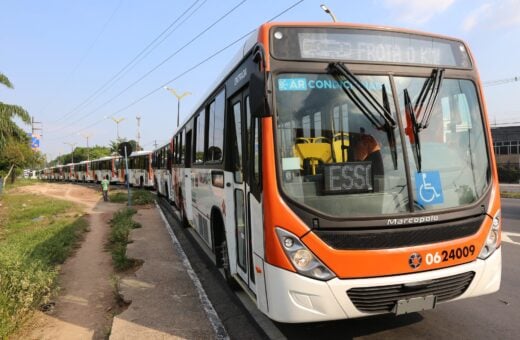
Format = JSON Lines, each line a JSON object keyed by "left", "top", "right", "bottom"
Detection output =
{"left": 404, "top": 69, "right": 444, "bottom": 172}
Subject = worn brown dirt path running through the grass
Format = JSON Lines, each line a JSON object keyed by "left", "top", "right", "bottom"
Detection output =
{"left": 13, "top": 184, "right": 122, "bottom": 339}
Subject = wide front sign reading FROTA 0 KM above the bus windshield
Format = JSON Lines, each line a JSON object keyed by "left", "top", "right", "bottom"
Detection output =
{"left": 273, "top": 27, "right": 471, "bottom": 68}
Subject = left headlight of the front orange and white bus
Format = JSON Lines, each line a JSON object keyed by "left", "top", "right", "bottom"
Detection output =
{"left": 276, "top": 228, "right": 335, "bottom": 281}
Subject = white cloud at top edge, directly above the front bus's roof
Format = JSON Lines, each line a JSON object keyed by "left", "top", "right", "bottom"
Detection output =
{"left": 385, "top": 0, "right": 455, "bottom": 24}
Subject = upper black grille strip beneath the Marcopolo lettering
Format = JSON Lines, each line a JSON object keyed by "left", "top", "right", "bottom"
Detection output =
{"left": 314, "top": 216, "right": 484, "bottom": 250}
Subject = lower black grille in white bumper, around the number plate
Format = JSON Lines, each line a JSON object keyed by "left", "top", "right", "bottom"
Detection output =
{"left": 347, "top": 272, "right": 475, "bottom": 313}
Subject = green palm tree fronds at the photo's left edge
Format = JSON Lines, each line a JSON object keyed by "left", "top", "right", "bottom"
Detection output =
{"left": 0, "top": 73, "right": 31, "bottom": 150}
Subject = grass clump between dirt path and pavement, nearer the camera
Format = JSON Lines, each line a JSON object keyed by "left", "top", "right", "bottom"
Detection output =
{"left": 108, "top": 208, "right": 141, "bottom": 271}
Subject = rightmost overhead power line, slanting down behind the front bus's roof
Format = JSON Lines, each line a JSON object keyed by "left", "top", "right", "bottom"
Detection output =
{"left": 45, "top": 0, "right": 304, "bottom": 141}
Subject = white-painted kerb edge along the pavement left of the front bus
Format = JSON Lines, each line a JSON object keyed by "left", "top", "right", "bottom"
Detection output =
{"left": 155, "top": 202, "right": 229, "bottom": 340}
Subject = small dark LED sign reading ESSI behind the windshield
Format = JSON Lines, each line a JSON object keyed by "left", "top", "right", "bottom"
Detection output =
{"left": 323, "top": 162, "right": 374, "bottom": 194}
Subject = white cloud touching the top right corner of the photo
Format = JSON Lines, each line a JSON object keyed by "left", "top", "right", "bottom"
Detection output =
{"left": 462, "top": 0, "right": 520, "bottom": 31}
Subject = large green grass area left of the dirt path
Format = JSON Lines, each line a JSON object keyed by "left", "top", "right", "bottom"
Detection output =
{"left": 0, "top": 194, "right": 88, "bottom": 339}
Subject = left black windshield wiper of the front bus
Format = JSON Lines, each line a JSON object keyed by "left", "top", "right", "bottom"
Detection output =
{"left": 329, "top": 62, "right": 397, "bottom": 170}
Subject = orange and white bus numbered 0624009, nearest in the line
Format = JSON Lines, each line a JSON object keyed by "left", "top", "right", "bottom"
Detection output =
{"left": 172, "top": 23, "right": 501, "bottom": 322}
